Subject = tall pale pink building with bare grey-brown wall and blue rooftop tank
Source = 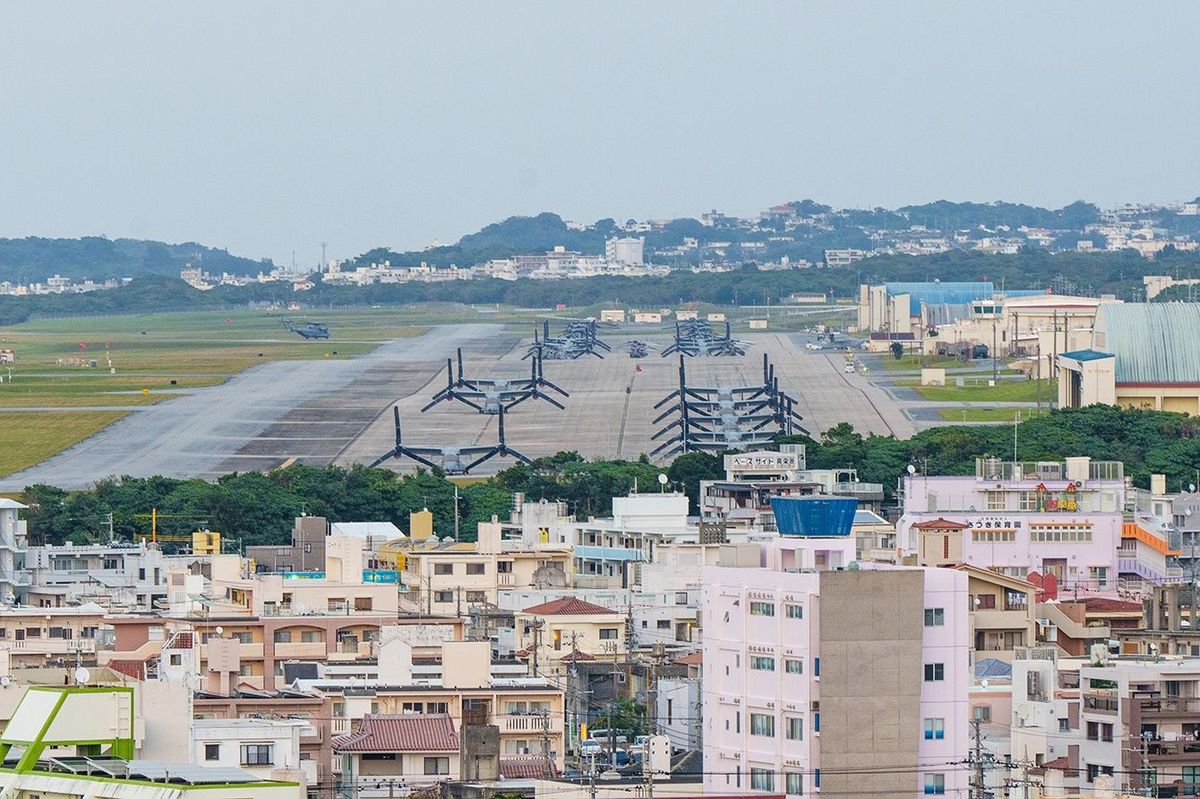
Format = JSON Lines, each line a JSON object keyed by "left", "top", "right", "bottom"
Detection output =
{"left": 703, "top": 498, "right": 970, "bottom": 797}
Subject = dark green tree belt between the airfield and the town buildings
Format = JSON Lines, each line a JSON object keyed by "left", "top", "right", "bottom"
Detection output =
{"left": 22, "top": 405, "right": 1200, "bottom": 546}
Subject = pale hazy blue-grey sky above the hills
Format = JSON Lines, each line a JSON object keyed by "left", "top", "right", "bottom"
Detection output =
{"left": 0, "top": 0, "right": 1200, "bottom": 264}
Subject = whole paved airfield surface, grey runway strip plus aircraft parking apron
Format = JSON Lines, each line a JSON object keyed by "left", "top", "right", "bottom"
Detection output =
{"left": 0, "top": 324, "right": 916, "bottom": 491}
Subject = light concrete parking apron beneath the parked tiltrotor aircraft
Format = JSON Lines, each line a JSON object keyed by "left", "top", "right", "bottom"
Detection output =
{"left": 338, "top": 334, "right": 916, "bottom": 474}
